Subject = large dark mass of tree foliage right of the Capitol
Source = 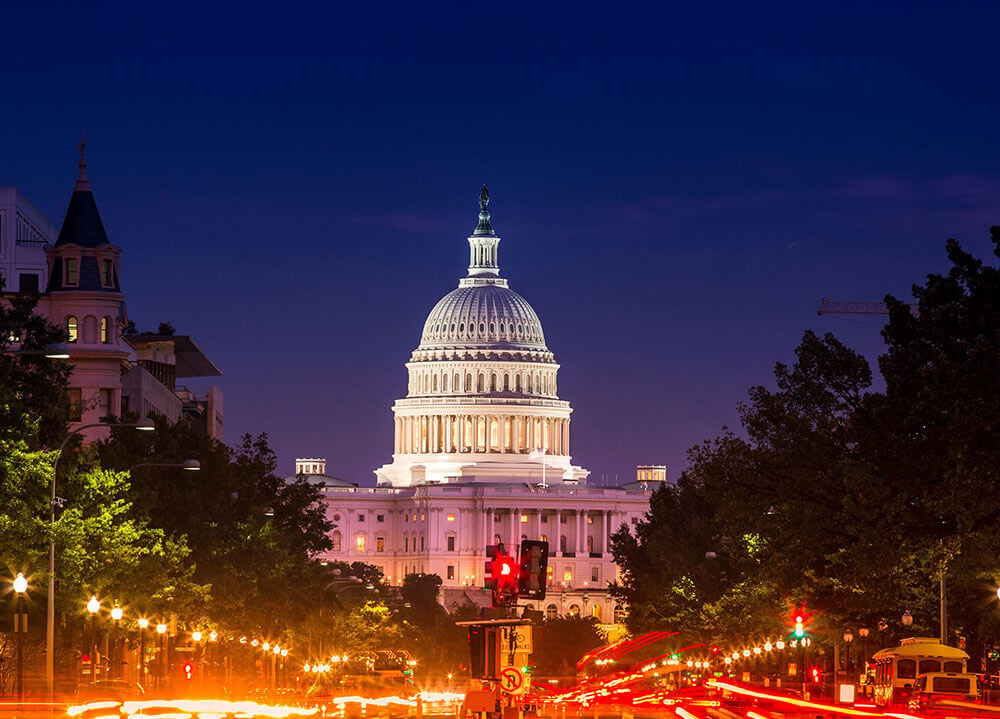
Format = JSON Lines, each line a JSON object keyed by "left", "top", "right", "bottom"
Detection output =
{"left": 613, "top": 228, "right": 1000, "bottom": 660}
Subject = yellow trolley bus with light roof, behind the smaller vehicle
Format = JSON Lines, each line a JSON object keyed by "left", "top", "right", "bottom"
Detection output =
{"left": 872, "top": 637, "right": 969, "bottom": 706}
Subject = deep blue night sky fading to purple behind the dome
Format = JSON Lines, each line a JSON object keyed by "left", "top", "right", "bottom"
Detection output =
{"left": 0, "top": 2, "right": 1000, "bottom": 484}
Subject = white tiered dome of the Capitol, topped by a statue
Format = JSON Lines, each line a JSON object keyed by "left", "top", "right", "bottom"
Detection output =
{"left": 375, "top": 185, "right": 588, "bottom": 487}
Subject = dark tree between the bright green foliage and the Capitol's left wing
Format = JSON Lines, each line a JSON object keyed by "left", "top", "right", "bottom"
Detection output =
{"left": 99, "top": 420, "right": 331, "bottom": 632}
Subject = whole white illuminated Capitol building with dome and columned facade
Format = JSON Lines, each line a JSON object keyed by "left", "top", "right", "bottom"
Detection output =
{"left": 296, "top": 186, "right": 659, "bottom": 624}
